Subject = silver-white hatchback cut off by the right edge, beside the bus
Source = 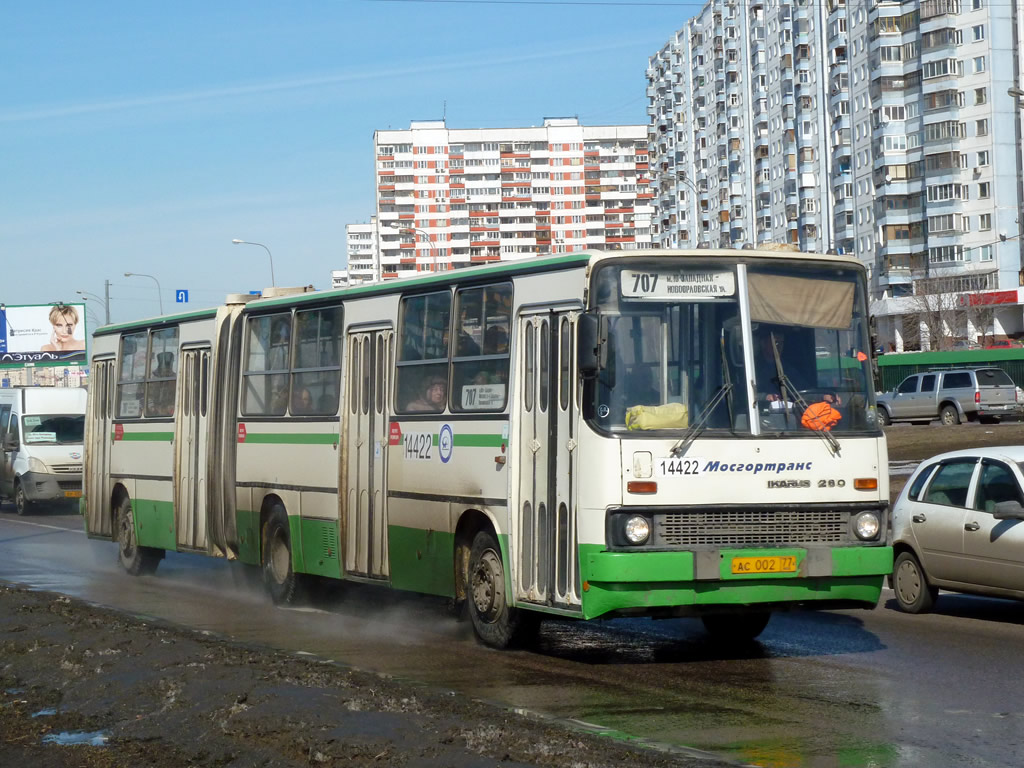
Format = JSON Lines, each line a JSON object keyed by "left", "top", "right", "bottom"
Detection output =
{"left": 892, "top": 445, "right": 1024, "bottom": 613}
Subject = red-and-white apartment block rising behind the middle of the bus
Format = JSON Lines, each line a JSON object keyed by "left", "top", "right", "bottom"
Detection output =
{"left": 372, "top": 118, "right": 653, "bottom": 279}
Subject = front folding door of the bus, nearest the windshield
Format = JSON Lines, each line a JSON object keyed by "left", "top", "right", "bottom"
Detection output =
{"left": 515, "top": 311, "right": 581, "bottom": 609}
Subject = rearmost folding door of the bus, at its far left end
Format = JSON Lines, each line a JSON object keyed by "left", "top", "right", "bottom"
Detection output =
{"left": 85, "top": 359, "right": 117, "bottom": 536}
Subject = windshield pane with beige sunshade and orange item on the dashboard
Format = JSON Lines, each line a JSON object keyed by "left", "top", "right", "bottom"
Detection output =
{"left": 748, "top": 264, "right": 876, "bottom": 432}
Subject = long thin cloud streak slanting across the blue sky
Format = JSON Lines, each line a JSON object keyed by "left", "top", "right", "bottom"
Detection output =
{"left": 0, "top": 40, "right": 646, "bottom": 123}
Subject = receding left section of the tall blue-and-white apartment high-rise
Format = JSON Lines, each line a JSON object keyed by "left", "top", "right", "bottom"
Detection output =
{"left": 647, "top": 0, "right": 835, "bottom": 251}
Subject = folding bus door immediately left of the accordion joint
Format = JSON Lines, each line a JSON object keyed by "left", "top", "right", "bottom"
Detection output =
{"left": 174, "top": 347, "right": 210, "bottom": 550}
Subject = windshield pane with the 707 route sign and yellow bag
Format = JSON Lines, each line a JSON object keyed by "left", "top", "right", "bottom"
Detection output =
{"left": 587, "top": 261, "right": 750, "bottom": 432}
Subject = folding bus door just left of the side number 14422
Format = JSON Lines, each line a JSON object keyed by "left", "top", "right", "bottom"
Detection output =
{"left": 343, "top": 329, "right": 394, "bottom": 579}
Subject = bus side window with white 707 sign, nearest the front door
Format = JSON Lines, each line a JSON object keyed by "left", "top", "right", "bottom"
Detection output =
{"left": 452, "top": 283, "right": 512, "bottom": 412}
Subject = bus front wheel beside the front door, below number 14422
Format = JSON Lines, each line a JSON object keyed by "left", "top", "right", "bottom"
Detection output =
{"left": 466, "top": 530, "right": 540, "bottom": 649}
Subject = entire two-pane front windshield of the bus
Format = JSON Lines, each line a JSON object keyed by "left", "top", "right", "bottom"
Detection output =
{"left": 584, "top": 259, "right": 878, "bottom": 435}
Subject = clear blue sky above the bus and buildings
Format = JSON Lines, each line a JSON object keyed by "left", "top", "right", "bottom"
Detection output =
{"left": 0, "top": 0, "right": 699, "bottom": 327}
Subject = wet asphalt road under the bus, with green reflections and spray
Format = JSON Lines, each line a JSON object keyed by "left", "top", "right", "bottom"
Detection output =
{"left": 0, "top": 506, "right": 1024, "bottom": 767}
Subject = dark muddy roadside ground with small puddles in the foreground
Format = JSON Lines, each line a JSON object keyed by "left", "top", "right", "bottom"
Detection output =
{"left": 0, "top": 586, "right": 728, "bottom": 768}
